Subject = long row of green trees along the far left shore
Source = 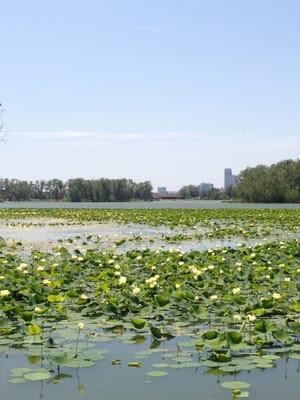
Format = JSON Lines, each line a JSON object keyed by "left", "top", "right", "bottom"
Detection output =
{"left": 0, "top": 178, "right": 152, "bottom": 202}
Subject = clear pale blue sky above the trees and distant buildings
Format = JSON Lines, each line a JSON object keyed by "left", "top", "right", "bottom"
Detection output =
{"left": 0, "top": 0, "right": 300, "bottom": 190}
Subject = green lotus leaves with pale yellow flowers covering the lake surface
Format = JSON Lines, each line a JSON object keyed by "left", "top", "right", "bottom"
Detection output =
{"left": 0, "top": 210, "right": 300, "bottom": 399}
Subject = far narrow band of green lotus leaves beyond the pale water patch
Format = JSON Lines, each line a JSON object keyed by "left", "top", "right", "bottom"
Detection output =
{"left": 0, "top": 208, "right": 300, "bottom": 230}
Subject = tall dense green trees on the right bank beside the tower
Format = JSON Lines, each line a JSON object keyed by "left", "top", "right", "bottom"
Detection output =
{"left": 235, "top": 159, "right": 300, "bottom": 203}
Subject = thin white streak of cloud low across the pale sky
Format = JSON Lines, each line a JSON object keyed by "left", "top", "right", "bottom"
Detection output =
{"left": 6, "top": 131, "right": 299, "bottom": 155}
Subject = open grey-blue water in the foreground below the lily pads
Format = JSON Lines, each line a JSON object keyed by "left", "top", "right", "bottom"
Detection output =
{"left": 0, "top": 335, "right": 300, "bottom": 400}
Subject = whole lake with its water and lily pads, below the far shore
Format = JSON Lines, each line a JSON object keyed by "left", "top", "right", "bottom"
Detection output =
{"left": 0, "top": 205, "right": 300, "bottom": 400}
